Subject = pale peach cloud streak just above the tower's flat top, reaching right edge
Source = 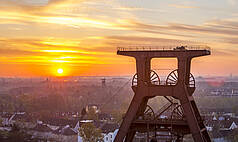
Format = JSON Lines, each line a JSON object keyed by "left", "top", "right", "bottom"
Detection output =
{"left": 119, "top": 20, "right": 238, "bottom": 42}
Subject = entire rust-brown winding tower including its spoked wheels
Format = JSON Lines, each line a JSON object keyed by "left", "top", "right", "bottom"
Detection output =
{"left": 114, "top": 46, "right": 211, "bottom": 142}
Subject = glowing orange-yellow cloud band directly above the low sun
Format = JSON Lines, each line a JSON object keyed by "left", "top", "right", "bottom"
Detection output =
{"left": 0, "top": 36, "right": 119, "bottom": 64}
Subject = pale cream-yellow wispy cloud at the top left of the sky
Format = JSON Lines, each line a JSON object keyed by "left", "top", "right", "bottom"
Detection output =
{"left": 0, "top": 0, "right": 134, "bottom": 30}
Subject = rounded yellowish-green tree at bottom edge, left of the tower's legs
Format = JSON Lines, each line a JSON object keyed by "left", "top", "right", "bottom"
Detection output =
{"left": 79, "top": 123, "right": 103, "bottom": 142}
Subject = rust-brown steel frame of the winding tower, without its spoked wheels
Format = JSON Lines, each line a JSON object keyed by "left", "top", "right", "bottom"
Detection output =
{"left": 114, "top": 46, "right": 211, "bottom": 142}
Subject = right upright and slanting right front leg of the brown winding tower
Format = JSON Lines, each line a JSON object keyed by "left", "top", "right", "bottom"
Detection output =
{"left": 177, "top": 57, "right": 211, "bottom": 142}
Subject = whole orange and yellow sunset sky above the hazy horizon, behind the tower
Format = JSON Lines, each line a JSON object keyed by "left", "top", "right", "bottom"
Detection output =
{"left": 0, "top": 0, "right": 238, "bottom": 76}
